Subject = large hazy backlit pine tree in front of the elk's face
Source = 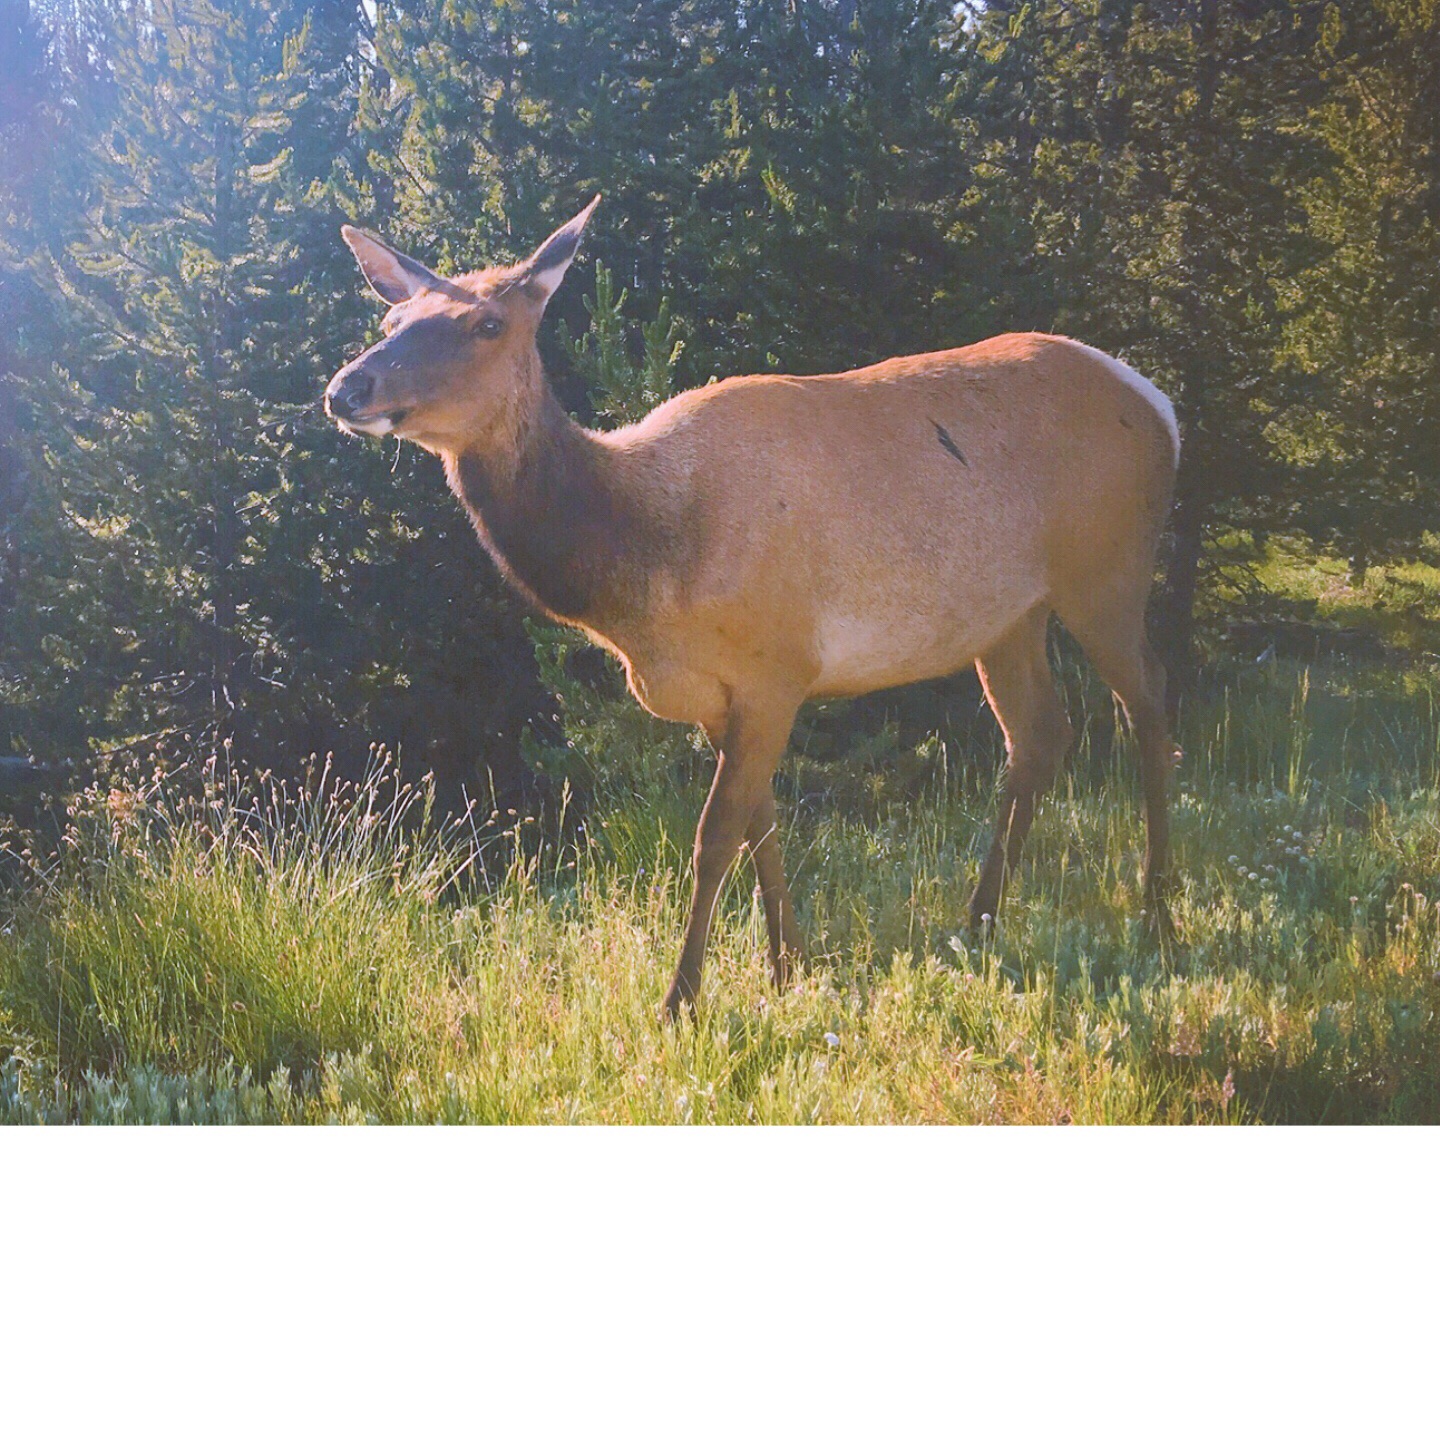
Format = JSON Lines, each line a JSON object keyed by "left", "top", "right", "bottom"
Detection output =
{"left": 12, "top": 0, "right": 541, "bottom": 798}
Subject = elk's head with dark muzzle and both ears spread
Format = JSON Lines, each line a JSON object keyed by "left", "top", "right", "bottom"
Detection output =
{"left": 325, "top": 196, "right": 600, "bottom": 454}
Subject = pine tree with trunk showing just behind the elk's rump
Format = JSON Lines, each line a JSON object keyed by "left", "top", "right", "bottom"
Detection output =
{"left": 976, "top": 0, "right": 1325, "bottom": 696}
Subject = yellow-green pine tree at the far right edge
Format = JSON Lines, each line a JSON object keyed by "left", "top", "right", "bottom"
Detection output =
{"left": 1272, "top": 0, "right": 1440, "bottom": 573}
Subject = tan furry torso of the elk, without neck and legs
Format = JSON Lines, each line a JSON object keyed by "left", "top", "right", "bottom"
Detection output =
{"left": 578, "top": 336, "right": 1174, "bottom": 727}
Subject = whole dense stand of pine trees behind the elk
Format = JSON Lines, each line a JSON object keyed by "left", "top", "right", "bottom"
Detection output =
{"left": 0, "top": 0, "right": 1440, "bottom": 796}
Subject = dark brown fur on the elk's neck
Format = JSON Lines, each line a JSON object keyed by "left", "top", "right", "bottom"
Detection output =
{"left": 445, "top": 380, "right": 661, "bottom": 634}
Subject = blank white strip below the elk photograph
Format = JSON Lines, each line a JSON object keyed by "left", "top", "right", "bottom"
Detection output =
{"left": 0, "top": 1129, "right": 1440, "bottom": 1440}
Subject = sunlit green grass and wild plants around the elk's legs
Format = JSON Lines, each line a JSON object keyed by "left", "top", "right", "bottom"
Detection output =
{"left": 0, "top": 665, "right": 1440, "bottom": 1123}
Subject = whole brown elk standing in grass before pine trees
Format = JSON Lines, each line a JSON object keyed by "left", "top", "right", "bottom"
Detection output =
{"left": 325, "top": 196, "right": 1179, "bottom": 1017}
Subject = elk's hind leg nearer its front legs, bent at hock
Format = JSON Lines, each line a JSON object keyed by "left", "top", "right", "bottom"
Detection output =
{"left": 971, "top": 605, "right": 1074, "bottom": 929}
